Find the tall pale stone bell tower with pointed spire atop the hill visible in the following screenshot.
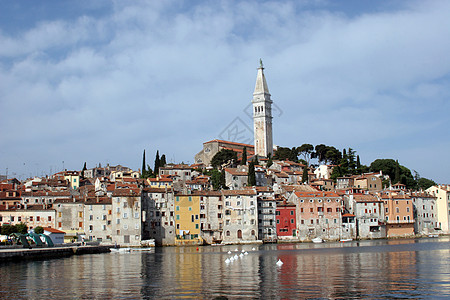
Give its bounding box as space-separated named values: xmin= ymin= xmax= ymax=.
xmin=252 ymin=60 xmax=273 ymax=157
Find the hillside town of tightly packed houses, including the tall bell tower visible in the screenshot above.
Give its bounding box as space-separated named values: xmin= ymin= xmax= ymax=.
xmin=0 ymin=62 xmax=450 ymax=246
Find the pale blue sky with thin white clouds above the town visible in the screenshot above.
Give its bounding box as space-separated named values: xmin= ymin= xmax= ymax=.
xmin=0 ymin=0 xmax=450 ymax=183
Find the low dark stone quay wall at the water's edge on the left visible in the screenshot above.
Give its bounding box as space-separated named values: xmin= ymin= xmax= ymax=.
xmin=0 ymin=246 xmax=110 ymax=263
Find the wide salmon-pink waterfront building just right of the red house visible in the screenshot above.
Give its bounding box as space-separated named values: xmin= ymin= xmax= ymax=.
xmin=288 ymin=190 xmax=342 ymax=241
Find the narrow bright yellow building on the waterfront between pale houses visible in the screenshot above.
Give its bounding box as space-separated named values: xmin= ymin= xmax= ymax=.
xmin=175 ymin=194 xmax=202 ymax=245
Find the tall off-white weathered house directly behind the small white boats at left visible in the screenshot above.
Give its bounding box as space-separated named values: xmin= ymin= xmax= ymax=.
xmin=111 ymin=188 xmax=142 ymax=246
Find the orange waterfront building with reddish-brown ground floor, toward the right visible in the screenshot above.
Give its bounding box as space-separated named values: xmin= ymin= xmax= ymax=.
xmin=381 ymin=193 xmax=414 ymax=237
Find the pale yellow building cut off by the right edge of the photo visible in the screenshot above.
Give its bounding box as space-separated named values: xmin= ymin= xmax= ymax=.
xmin=426 ymin=184 xmax=450 ymax=234
